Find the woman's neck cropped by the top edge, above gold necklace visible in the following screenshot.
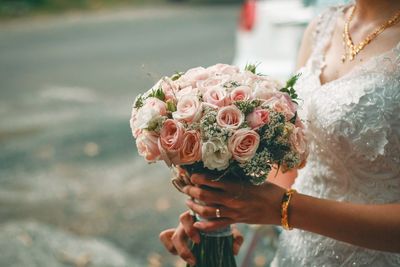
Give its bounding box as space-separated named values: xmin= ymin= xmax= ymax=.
xmin=354 ymin=0 xmax=400 ymax=22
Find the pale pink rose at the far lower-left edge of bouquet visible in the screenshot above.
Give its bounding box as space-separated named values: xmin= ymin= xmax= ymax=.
xmin=136 ymin=131 xmax=160 ymax=162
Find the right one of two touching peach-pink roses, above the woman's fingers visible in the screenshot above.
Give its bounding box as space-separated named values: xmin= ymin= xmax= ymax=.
xmin=179 ymin=130 xmax=201 ymax=165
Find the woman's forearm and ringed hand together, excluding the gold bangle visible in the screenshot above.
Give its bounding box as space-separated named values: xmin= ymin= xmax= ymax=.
xmin=184 ymin=175 xmax=400 ymax=253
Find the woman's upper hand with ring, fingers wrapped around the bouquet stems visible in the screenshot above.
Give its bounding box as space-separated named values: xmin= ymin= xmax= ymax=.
xmin=183 ymin=174 xmax=285 ymax=231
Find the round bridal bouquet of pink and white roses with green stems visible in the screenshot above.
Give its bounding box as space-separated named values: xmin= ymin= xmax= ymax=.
xmin=130 ymin=64 xmax=307 ymax=267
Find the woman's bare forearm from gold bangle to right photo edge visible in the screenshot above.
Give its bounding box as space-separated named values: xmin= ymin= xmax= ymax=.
xmin=289 ymin=194 xmax=400 ymax=253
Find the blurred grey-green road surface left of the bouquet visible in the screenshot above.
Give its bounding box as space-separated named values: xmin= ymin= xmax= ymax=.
xmin=0 ymin=6 xmax=238 ymax=267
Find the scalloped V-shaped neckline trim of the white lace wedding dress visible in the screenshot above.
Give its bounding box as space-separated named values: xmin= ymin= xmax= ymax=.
xmin=315 ymin=4 xmax=400 ymax=88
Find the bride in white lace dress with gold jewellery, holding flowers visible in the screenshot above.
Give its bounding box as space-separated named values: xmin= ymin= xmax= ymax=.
xmin=160 ymin=0 xmax=400 ymax=267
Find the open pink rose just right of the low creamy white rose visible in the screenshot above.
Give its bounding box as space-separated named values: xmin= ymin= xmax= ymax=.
xmin=228 ymin=129 xmax=260 ymax=163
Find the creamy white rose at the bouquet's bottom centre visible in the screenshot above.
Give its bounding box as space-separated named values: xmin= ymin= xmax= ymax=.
xmin=201 ymin=138 xmax=232 ymax=171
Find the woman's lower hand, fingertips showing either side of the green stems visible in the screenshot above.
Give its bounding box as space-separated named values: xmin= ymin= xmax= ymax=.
xmin=160 ymin=211 xmax=243 ymax=265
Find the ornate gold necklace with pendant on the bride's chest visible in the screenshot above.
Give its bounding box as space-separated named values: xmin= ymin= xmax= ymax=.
xmin=342 ymin=5 xmax=400 ymax=63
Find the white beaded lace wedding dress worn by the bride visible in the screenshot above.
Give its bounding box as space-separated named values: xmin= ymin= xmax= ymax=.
xmin=271 ymin=6 xmax=400 ymax=267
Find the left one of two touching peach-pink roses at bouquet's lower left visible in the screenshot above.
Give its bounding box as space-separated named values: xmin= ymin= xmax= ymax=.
xmin=158 ymin=119 xmax=185 ymax=166
